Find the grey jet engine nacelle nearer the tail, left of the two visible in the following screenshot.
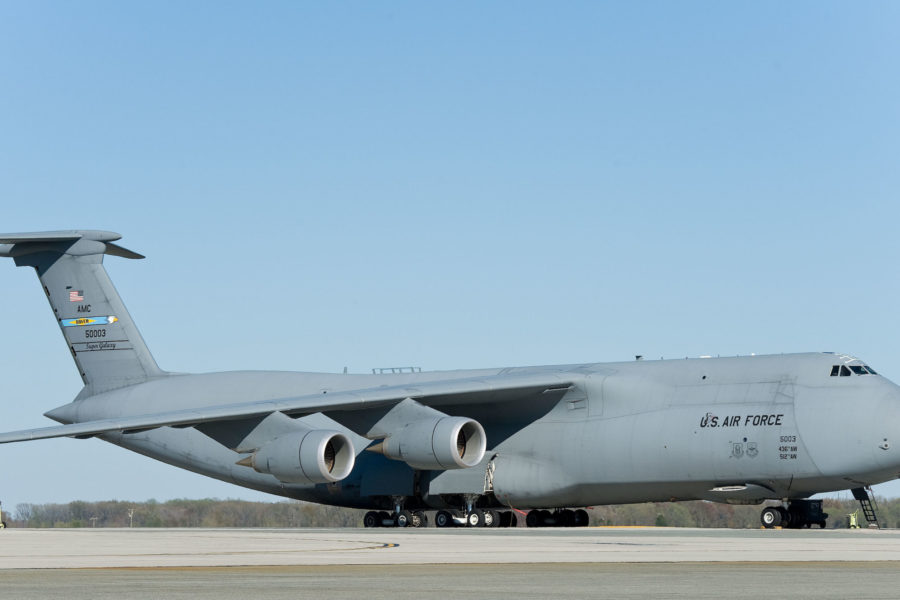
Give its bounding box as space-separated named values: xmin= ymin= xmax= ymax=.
xmin=250 ymin=429 xmax=356 ymax=483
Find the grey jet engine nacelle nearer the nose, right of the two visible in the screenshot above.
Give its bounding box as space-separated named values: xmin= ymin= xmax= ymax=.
xmin=381 ymin=417 xmax=487 ymax=470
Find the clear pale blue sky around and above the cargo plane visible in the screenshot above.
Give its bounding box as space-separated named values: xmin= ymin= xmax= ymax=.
xmin=0 ymin=1 xmax=900 ymax=509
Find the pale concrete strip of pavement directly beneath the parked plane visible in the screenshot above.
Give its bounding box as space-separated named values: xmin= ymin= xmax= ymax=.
xmin=0 ymin=527 xmax=900 ymax=569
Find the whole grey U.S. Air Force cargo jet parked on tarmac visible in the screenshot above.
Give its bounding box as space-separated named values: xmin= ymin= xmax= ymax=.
xmin=0 ymin=231 xmax=900 ymax=527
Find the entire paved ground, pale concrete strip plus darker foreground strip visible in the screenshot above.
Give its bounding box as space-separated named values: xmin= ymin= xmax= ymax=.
xmin=0 ymin=528 xmax=900 ymax=600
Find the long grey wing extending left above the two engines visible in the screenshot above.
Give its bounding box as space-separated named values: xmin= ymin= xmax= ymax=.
xmin=0 ymin=373 xmax=572 ymax=444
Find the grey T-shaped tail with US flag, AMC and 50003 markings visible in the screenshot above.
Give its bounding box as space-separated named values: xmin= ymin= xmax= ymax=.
xmin=0 ymin=231 xmax=165 ymax=394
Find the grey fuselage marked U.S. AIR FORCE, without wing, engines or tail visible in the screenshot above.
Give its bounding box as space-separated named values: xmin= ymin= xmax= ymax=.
xmin=48 ymin=353 xmax=900 ymax=508
